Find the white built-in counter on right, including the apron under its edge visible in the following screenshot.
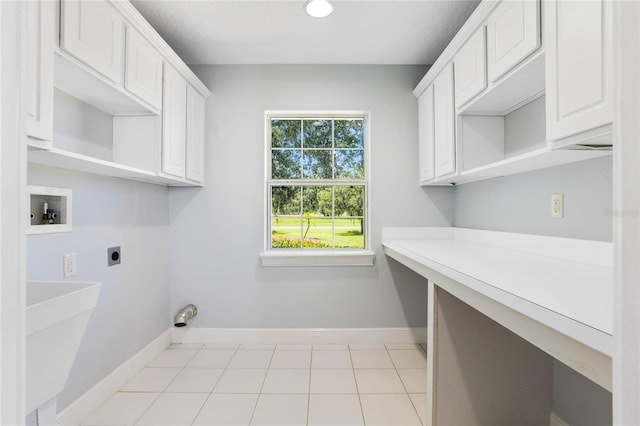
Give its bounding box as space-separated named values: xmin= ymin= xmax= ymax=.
xmin=382 ymin=228 xmax=614 ymax=389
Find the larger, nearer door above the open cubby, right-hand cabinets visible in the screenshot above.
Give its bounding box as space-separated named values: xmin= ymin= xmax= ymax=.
xmin=487 ymin=0 xmax=540 ymax=81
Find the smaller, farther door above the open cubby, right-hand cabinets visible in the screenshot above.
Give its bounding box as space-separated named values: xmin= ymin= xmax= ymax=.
xmin=453 ymin=26 xmax=487 ymax=107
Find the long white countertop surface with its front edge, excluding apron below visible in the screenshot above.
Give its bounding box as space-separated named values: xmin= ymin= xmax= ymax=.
xmin=382 ymin=228 xmax=613 ymax=356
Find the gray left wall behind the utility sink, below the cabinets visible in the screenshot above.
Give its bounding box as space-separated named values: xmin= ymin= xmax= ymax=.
xmin=27 ymin=164 xmax=171 ymax=410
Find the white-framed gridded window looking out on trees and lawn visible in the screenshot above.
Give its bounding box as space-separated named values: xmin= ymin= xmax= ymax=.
xmin=263 ymin=112 xmax=370 ymax=263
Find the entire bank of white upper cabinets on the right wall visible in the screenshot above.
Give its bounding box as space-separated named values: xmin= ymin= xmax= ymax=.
xmin=413 ymin=0 xmax=613 ymax=185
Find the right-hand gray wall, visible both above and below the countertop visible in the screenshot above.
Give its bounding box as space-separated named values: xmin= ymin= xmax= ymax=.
xmin=454 ymin=156 xmax=613 ymax=426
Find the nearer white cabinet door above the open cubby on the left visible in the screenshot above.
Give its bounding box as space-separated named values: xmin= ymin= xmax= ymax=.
xmin=60 ymin=0 xmax=124 ymax=84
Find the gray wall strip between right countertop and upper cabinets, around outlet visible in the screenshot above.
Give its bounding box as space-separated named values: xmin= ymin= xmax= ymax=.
xmin=454 ymin=156 xmax=612 ymax=241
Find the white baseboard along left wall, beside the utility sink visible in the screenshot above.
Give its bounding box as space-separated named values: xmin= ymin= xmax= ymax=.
xmin=57 ymin=330 xmax=172 ymax=426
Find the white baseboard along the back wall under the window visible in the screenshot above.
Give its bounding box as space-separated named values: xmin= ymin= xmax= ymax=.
xmin=171 ymin=327 xmax=427 ymax=345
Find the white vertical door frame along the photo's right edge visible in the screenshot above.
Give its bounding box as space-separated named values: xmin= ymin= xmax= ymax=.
xmin=612 ymin=1 xmax=640 ymax=425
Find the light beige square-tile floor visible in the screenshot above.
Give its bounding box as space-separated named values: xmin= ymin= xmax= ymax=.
xmin=82 ymin=344 xmax=427 ymax=426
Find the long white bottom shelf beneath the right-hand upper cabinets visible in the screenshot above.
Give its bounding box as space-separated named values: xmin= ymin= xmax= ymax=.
xmin=425 ymin=148 xmax=611 ymax=185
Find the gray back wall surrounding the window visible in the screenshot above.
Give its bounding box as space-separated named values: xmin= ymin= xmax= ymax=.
xmin=169 ymin=65 xmax=453 ymax=328
